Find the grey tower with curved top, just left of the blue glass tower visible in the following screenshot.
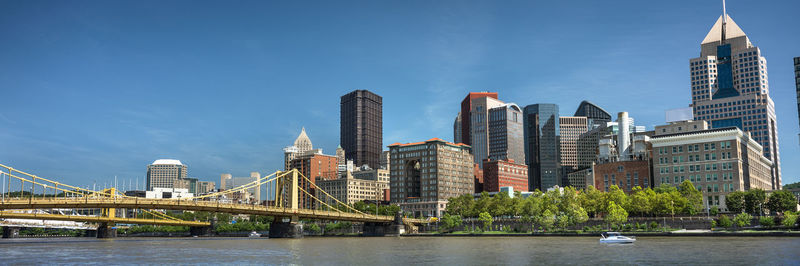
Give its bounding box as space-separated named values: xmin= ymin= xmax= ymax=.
xmin=488 ymin=103 xmax=527 ymax=164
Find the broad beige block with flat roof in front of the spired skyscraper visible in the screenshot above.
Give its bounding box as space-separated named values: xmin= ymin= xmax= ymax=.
xmin=650 ymin=122 xmax=773 ymax=211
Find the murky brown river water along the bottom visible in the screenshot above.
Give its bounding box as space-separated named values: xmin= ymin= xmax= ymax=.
xmin=0 ymin=237 xmax=800 ymax=266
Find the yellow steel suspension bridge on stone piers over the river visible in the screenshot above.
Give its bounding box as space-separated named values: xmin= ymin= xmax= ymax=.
xmin=0 ymin=164 xmax=427 ymax=238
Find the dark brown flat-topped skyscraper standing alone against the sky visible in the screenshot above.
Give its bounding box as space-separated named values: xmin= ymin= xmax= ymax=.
xmin=339 ymin=90 xmax=383 ymax=169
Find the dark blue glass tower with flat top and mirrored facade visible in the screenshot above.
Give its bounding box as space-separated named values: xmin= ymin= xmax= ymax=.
xmin=523 ymin=103 xmax=563 ymax=191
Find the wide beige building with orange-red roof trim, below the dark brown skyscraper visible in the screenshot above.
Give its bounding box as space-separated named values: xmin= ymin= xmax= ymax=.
xmin=389 ymin=138 xmax=475 ymax=217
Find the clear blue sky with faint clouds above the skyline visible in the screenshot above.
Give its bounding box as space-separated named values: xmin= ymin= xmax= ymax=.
xmin=0 ymin=0 xmax=800 ymax=189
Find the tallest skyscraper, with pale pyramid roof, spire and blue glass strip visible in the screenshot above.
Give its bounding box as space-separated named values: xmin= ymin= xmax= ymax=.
xmin=689 ymin=8 xmax=781 ymax=189
